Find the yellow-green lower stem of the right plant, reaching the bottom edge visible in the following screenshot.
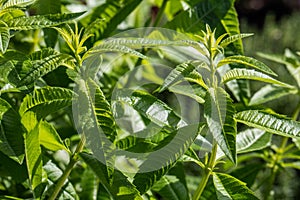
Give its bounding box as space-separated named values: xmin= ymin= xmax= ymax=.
xmin=193 ymin=144 xmax=218 ymax=200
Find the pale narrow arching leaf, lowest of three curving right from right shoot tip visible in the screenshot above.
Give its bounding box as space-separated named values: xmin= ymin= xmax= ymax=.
xmin=222 ymin=68 xmax=294 ymax=88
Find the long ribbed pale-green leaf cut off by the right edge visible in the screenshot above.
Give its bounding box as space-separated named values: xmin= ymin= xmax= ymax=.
xmin=235 ymin=110 xmax=300 ymax=137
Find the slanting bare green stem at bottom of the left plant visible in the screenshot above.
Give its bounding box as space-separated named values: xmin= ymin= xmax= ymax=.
xmin=49 ymin=135 xmax=85 ymax=200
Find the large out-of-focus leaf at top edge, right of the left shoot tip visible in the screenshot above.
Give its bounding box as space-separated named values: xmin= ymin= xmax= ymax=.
xmin=80 ymin=0 xmax=142 ymax=44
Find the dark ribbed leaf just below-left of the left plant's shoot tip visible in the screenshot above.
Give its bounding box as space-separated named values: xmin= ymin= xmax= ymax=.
xmin=17 ymin=48 xmax=72 ymax=86
